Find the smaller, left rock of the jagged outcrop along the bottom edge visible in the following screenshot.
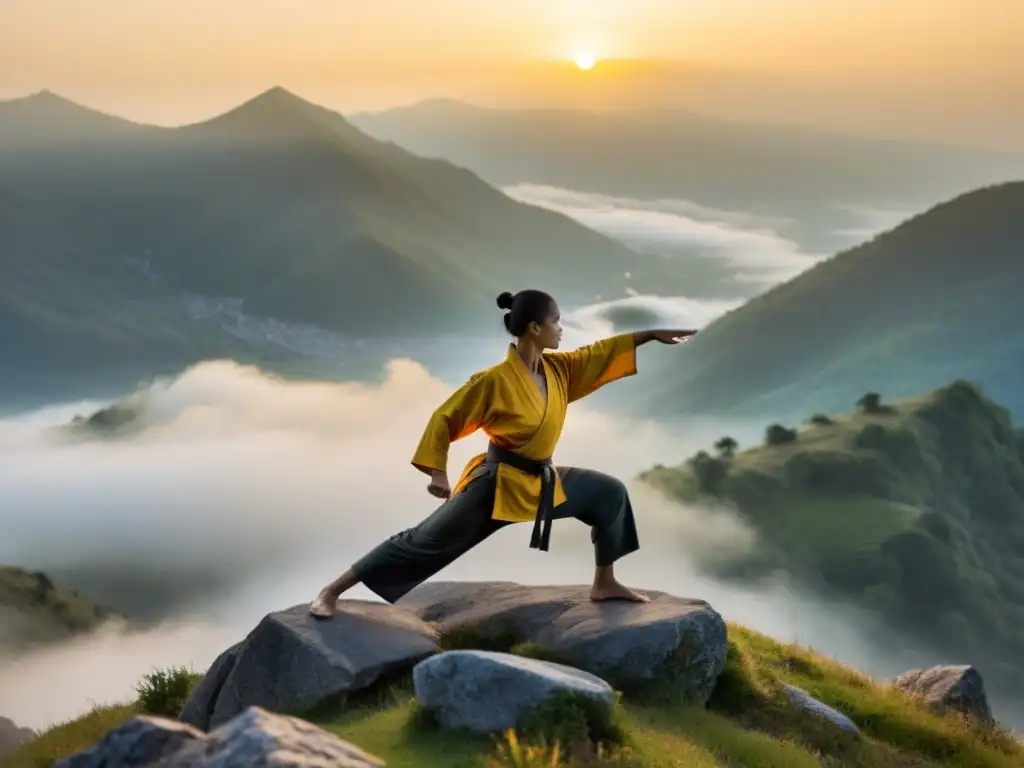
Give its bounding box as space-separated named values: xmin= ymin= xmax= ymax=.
xmin=54 ymin=716 xmax=205 ymax=768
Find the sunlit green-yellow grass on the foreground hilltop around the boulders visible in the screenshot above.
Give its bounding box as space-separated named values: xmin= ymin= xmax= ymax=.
xmin=7 ymin=626 xmax=1024 ymax=768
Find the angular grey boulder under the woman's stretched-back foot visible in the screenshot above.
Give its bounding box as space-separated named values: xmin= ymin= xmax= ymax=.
xmin=179 ymin=600 xmax=437 ymax=730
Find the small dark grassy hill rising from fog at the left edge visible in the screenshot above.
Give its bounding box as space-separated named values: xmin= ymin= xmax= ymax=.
xmin=0 ymin=566 xmax=116 ymax=655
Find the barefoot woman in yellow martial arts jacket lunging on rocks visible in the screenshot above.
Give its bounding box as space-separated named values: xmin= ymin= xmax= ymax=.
xmin=309 ymin=290 xmax=696 ymax=618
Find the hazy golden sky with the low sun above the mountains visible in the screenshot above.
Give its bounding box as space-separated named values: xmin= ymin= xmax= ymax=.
xmin=0 ymin=0 xmax=1024 ymax=145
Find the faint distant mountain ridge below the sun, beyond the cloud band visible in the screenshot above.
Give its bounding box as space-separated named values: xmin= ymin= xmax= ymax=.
xmin=349 ymin=99 xmax=1024 ymax=250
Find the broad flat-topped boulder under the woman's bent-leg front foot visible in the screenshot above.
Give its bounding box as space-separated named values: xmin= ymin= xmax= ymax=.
xmin=397 ymin=582 xmax=728 ymax=707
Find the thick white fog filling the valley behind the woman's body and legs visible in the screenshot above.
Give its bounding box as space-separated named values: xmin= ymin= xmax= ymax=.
xmin=0 ymin=358 xmax=950 ymax=728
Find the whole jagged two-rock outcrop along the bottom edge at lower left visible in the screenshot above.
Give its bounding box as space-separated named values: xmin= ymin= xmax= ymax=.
xmin=55 ymin=708 xmax=384 ymax=768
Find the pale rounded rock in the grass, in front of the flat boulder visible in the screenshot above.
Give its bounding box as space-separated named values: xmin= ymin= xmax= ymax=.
xmin=413 ymin=650 xmax=615 ymax=733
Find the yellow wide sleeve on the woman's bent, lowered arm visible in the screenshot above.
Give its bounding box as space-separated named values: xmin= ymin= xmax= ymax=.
xmin=413 ymin=373 xmax=494 ymax=473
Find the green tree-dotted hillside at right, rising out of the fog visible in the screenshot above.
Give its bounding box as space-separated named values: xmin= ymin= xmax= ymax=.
xmin=642 ymin=382 xmax=1024 ymax=699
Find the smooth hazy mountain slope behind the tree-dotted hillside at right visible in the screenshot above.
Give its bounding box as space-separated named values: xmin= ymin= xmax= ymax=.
xmin=629 ymin=182 xmax=1024 ymax=420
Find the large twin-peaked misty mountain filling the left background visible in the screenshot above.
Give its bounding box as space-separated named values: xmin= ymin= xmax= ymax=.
xmin=0 ymin=88 xmax=681 ymax=409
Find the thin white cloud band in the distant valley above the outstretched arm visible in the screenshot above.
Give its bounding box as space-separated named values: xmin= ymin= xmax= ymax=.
xmin=504 ymin=184 xmax=822 ymax=285
